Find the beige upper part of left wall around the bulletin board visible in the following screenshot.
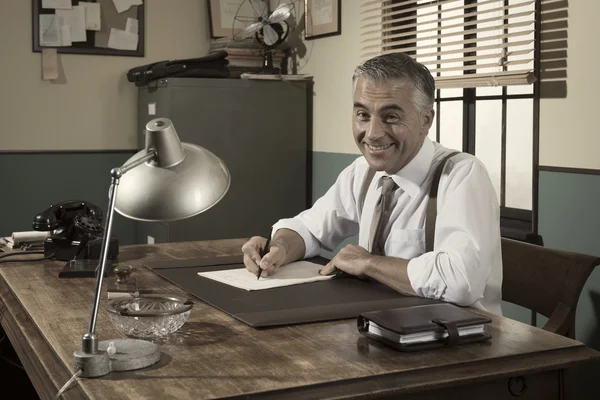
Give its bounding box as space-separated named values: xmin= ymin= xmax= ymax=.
xmin=0 ymin=0 xmax=210 ymax=151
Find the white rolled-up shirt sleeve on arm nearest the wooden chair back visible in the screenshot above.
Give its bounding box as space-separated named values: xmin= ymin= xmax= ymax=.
xmin=407 ymin=159 xmax=500 ymax=306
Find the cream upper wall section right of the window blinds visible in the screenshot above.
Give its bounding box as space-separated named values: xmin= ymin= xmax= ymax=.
xmin=540 ymin=0 xmax=600 ymax=169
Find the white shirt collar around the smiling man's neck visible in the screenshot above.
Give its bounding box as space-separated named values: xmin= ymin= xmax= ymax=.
xmin=375 ymin=137 xmax=435 ymax=197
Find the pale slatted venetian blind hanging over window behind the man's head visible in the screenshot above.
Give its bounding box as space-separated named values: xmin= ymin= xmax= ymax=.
xmin=361 ymin=0 xmax=536 ymax=88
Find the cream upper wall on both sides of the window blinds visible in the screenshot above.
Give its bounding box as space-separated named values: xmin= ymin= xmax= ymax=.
xmin=298 ymin=0 xmax=600 ymax=169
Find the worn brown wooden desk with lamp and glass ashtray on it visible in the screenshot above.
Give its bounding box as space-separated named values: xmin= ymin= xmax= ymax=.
xmin=0 ymin=239 xmax=599 ymax=399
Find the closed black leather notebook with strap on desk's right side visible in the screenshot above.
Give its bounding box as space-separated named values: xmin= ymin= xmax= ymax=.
xmin=357 ymin=303 xmax=491 ymax=351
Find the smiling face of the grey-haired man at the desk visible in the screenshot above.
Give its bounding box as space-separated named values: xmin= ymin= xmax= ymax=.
xmin=352 ymin=77 xmax=434 ymax=174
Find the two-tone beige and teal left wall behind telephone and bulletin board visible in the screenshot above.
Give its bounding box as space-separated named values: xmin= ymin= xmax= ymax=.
xmin=0 ymin=0 xmax=210 ymax=244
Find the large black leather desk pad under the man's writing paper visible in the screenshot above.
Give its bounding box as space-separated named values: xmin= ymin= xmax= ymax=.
xmin=144 ymin=256 xmax=437 ymax=328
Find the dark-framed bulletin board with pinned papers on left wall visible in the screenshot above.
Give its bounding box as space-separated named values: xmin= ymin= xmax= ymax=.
xmin=32 ymin=0 xmax=145 ymax=57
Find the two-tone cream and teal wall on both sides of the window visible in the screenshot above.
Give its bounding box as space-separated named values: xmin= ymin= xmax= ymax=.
xmin=298 ymin=0 xmax=600 ymax=356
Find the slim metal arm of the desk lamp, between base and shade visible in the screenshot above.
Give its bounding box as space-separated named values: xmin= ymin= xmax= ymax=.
xmin=82 ymin=149 xmax=157 ymax=354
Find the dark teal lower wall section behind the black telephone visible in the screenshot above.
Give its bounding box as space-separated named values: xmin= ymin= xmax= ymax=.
xmin=0 ymin=152 xmax=135 ymax=245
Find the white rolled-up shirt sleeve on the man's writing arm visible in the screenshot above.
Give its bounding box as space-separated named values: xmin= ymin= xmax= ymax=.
xmin=271 ymin=161 xmax=358 ymax=258
